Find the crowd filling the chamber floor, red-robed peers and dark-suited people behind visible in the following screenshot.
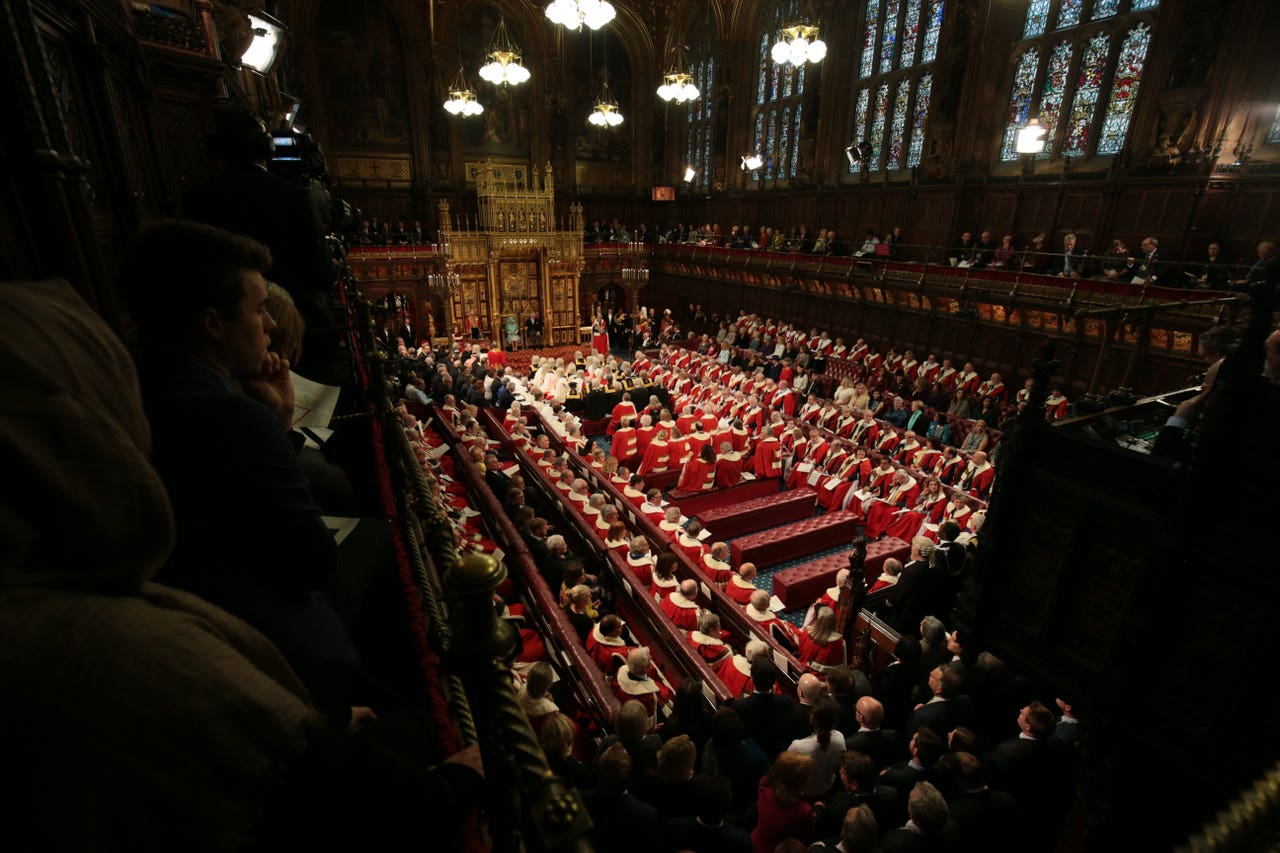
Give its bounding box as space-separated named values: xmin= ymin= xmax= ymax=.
xmin=381 ymin=297 xmax=1078 ymax=850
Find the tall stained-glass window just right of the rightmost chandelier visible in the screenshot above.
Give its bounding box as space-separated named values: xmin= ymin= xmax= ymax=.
xmin=849 ymin=0 xmax=943 ymax=172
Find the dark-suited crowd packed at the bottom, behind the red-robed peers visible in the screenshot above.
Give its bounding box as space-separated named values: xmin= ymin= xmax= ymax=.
xmin=476 ymin=394 xmax=1073 ymax=849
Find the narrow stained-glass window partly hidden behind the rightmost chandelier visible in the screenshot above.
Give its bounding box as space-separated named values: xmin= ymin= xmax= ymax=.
xmin=749 ymin=0 xmax=803 ymax=182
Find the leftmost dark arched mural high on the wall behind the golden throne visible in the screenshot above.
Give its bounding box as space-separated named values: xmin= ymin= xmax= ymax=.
xmin=316 ymin=0 xmax=410 ymax=149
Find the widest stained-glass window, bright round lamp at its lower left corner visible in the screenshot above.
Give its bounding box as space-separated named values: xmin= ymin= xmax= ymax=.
xmin=998 ymin=0 xmax=1160 ymax=161
